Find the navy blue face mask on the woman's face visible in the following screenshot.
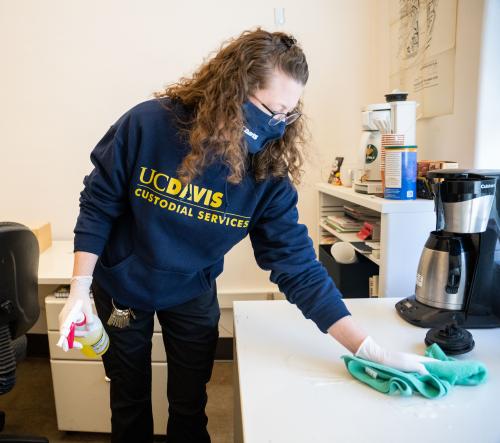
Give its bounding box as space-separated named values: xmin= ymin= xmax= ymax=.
xmin=243 ymin=101 xmax=286 ymax=154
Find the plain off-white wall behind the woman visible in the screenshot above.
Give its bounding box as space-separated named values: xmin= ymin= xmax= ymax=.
xmin=0 ymin=0 xmax=385 ymax=290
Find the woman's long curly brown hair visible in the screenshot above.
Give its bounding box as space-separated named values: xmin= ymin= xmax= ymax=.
xmin=154 ymin=28 xmax=309 ymax=184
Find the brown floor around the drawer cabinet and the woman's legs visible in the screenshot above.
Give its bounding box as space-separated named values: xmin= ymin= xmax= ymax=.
xmin=0 ymin=357 xmax=233 ymax=443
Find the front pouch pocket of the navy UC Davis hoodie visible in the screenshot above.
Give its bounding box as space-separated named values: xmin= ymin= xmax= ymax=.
xmin=98 ymin=253 xmax=210 ymax=309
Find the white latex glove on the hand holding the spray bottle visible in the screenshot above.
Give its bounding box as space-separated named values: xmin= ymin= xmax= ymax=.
xmin=57 ymin=275 xmax=93 ymax=352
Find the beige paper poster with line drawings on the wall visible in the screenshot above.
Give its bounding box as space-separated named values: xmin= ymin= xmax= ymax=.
xmin=389 ymin=0 xmax=457 ymax=118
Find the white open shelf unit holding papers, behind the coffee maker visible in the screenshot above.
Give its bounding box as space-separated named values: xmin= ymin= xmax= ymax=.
xmin=316 ymin=183 xmax=436 ymax=298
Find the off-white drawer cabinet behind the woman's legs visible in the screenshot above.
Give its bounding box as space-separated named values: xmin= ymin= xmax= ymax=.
xmin=45 ymin=295 xmax=168 ymax=435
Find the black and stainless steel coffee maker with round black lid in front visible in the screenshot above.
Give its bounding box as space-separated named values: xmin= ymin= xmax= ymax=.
xmin=396 ymin=169 xmax=500 ymax=353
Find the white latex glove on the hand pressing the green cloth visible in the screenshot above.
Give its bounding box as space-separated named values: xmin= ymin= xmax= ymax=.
xmin=354 ymin=336 xmax=436 ymax=375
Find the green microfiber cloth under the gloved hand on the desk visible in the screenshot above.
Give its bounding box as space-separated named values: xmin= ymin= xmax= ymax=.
xmin=342 ymin=343 xmax=488 ymax=399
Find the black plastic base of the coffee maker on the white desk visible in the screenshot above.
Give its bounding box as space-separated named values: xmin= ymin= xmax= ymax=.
xmin=396 ymin=295 xmax=500 ymax=329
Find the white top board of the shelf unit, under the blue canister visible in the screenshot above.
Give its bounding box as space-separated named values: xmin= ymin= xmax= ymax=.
xmin=316 ymin=183 xmax=434 ymax=213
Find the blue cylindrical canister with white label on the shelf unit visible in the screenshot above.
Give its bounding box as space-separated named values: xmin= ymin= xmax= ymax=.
xmin=384 ymin=145 xmax=417 ymax=200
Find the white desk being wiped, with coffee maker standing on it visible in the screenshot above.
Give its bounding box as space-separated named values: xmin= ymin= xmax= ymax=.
xmin=234 ymin=298 xmax=500 ymax=443
